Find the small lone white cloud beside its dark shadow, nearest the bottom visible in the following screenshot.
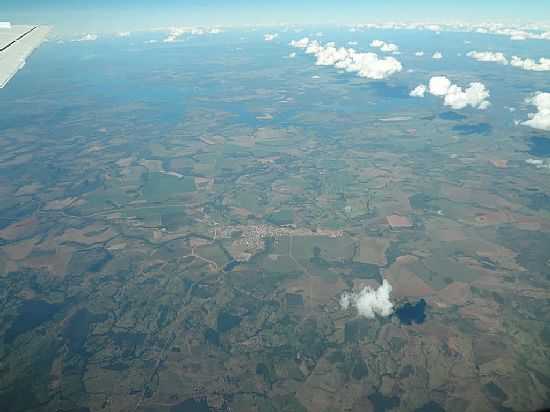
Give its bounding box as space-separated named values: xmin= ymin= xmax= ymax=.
xmin=340 ymin=279 xmax=393 ymax=319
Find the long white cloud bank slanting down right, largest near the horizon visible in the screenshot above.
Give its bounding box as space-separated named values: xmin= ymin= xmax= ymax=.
xmin=290 ymin=38 xmax=403 ymax=80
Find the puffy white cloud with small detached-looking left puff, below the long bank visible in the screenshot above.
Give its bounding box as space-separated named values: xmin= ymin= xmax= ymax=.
xmin=409 ymin=76 xmax=491 ymax=110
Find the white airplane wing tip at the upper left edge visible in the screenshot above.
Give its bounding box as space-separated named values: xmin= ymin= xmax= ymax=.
xmin=0 ymin=25 xmax=50 ymax=89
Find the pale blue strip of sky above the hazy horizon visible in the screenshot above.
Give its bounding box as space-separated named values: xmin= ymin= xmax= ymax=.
xmin=0 ymin=0 xmax=550 ymax=33
